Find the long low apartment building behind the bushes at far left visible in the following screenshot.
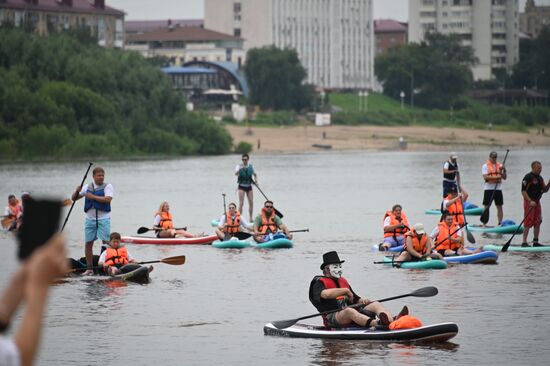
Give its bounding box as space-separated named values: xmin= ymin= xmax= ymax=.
xmin=0 ymin=0 xmax=125 ymax=47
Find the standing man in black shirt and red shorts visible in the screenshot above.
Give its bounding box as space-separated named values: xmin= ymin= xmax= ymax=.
xmin=521 ymin=161 xmax=550 ymax=247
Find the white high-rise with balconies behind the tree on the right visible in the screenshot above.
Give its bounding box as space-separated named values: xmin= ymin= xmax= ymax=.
xmin=409 ymin=0 xmax=519 ymax=80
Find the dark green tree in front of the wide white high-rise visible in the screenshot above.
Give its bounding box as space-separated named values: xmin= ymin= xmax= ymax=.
xmin=245 ymin=46 xmax=313 ymax=110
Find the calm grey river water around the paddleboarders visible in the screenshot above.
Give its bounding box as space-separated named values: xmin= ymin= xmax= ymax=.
xmin=0 ymin=150 xmax=550 ymax=366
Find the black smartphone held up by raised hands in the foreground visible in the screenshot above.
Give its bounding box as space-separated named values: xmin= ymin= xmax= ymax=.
xmin=18 ymin=198 xmax=61 ymax=260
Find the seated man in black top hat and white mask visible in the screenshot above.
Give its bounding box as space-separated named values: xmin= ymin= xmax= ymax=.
xmin=309 ymin=251 xmax=409 ymax=328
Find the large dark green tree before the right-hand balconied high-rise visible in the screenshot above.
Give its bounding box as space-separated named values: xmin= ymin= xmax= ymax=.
xmin=375 ymin=33 xmax=476 ymax=108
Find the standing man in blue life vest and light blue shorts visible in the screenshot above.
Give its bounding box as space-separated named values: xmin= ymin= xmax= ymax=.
xmin=71 ymin=166 xmax=114 ymax=275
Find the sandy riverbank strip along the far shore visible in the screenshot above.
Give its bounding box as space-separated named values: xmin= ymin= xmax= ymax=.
xmin=227 ymin=125 xmax=550 ymax=154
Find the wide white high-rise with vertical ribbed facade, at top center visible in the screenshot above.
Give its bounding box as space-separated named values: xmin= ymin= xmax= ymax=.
xmin=204 ymin=0 xmax=374 ymax=89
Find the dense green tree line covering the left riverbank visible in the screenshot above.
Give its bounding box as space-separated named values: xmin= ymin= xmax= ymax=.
xmin=0 ymin=26 xmax=232 ymax=159
